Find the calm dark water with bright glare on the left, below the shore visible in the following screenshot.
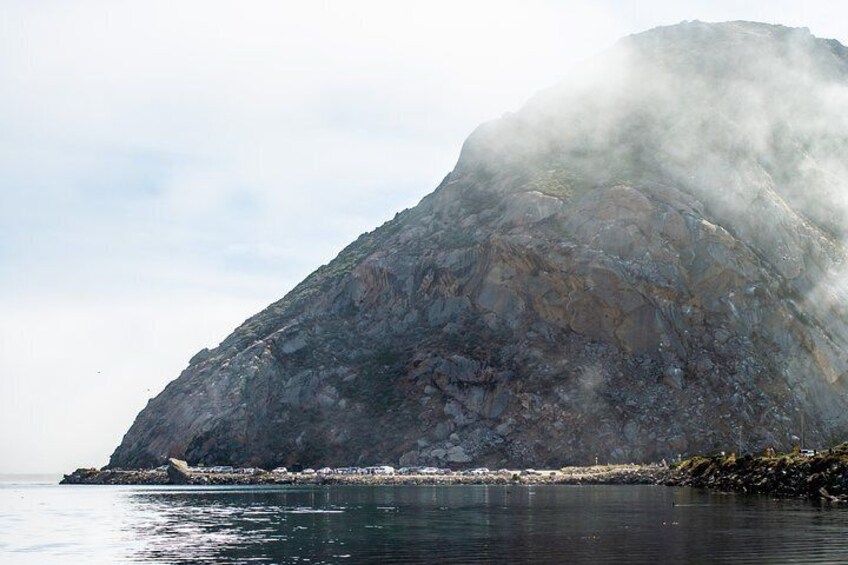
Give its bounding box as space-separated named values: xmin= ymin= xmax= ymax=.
xmin=0 ymin=476 xmax=848 ymax=565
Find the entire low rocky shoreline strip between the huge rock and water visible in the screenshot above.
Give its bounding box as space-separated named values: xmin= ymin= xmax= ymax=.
xmin=60 ymin=443 xmax=848 ymax=503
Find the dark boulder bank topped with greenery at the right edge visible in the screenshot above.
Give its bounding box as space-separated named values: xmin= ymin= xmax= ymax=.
xmin=664 ymin=444 xmax=848 ymax=502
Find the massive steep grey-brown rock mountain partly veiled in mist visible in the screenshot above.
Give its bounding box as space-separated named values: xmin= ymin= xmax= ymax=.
xmin=110 ymin=22 xmax=848 ymax=467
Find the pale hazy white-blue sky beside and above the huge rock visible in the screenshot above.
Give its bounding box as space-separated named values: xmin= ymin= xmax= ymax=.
xmin=0 ymin=0 xmax=848 ymax=473
